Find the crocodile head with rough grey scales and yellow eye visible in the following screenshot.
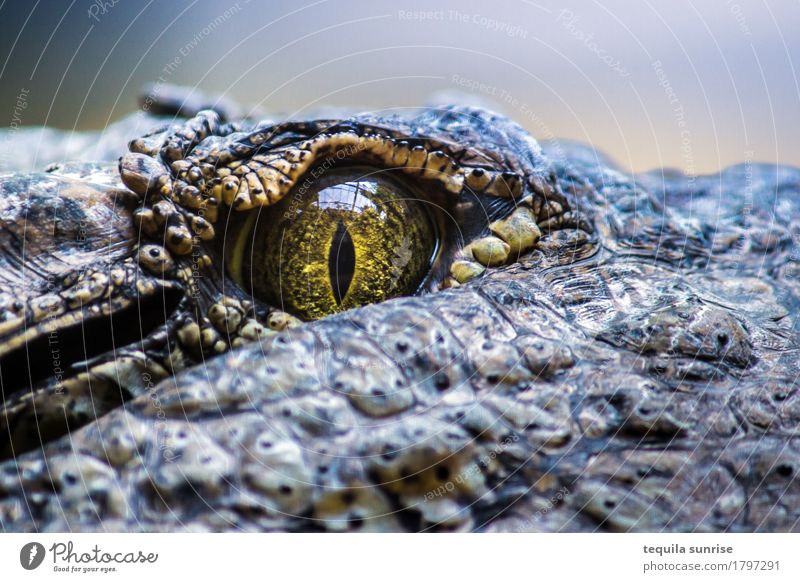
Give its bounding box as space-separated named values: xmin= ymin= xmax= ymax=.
xmin=0 ymin=88 xmax=800 ymax=532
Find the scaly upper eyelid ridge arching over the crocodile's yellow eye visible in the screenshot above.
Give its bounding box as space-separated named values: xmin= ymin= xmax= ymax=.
xmin=120 ymin=110 xmax=574 ymax=290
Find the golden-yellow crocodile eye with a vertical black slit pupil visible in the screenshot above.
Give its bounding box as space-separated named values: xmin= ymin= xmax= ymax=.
xmin=226 ymin=168 xmax=439 ymax=320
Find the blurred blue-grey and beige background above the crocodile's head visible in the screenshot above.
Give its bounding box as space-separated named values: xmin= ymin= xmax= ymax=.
xmin=0 ymin=0 xmax=800 ymax=174
